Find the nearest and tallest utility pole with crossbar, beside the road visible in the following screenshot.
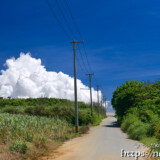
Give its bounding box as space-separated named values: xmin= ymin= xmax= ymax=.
xmin=70 ymin=40 xmax=84 ymax=132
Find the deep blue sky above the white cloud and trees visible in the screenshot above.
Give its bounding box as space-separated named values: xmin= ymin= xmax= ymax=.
xmin=0 ymin=0 xmax=160 ymax=104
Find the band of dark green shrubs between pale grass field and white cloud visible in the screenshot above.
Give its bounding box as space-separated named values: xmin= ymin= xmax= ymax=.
xmin=0 ymin=98 xmax=106 ymax=125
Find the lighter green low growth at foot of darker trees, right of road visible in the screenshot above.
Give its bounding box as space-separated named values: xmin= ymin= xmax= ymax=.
xmin=121 ymin=113 xmax=160 ymax=159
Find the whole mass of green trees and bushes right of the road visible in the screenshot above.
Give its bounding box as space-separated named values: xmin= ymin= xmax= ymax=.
xmin=112 ymin=80 xmax=160 ymax=145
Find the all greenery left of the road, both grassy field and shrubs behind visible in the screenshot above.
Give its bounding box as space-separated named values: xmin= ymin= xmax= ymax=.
xmin=0 ymin=98 xmax=105 ymax=159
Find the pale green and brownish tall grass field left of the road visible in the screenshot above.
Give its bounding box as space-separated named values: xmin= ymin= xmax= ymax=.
xmin=0 ymin=113 xmax=73 ymax=159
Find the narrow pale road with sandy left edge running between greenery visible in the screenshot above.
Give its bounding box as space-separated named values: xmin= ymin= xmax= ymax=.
xmin=42 ymin=116 xmax=143 ymax=160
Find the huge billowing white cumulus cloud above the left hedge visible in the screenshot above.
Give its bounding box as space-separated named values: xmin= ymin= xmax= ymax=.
xmin=0 ymin=53 xmax=106 ymax=103
